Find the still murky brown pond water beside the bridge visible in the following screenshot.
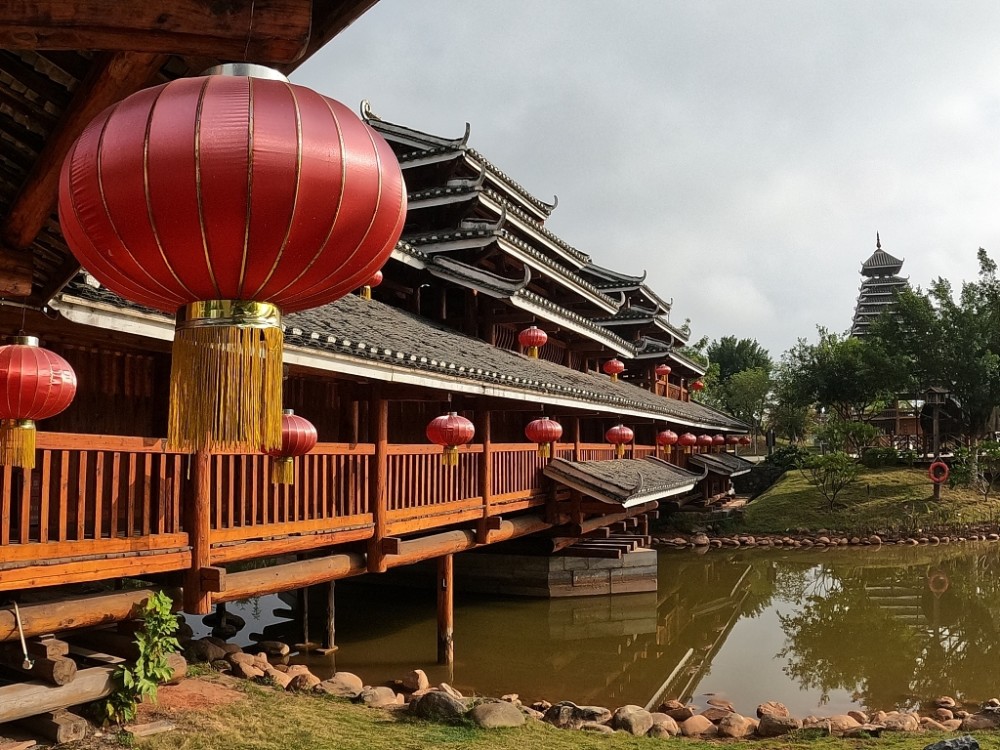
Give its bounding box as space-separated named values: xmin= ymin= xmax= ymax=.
xmin=189 ymin=543 xmax=1000 ymax=716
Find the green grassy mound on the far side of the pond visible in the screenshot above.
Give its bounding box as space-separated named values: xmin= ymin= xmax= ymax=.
xmin=726 ymin=468 xmax=1000 ymax=535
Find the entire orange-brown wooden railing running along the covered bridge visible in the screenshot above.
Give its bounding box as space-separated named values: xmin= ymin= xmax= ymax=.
xmin=0 ymin=433 xmax=672 ymax=590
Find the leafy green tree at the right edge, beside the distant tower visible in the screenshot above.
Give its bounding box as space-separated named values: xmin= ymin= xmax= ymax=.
xmin=872 ymin=248 xmax=1000 ymax=474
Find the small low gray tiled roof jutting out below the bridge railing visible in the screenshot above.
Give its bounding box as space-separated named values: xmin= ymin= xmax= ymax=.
xmin=543 ymin=458 xmax=705 ymax=505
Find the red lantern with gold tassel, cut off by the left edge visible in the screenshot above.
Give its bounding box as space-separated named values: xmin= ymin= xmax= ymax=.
xmin=0 ymin=336 xmax=76 ymax=469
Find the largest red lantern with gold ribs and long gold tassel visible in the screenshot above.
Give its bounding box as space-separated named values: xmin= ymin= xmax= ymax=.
xmin=59 ymin=65 xmax=406 ymax=453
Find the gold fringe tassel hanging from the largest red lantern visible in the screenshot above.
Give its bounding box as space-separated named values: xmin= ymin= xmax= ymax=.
xmin=167 ymin=300 xmax=284 ymax=453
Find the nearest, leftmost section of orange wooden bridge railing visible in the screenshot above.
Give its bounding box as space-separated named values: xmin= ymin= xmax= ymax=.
xmin=0 ymin=433 xmax=190 ymax=589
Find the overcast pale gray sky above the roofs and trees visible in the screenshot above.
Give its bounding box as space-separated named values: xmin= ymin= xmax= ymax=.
xmin=293 ymin=0 xmax=1000 ymax=358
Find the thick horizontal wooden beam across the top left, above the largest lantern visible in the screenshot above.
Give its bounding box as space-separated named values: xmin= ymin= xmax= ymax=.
xmin=0 ymin=0 xmax=310 ymax=63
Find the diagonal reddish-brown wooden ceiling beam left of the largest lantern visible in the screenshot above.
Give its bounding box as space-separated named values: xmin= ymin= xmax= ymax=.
xmin=0 ymin=47 xmax=166 ymax=302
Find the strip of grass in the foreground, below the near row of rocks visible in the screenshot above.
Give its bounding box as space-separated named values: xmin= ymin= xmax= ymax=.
xmin=135 ymin=677 xmax=1000 ymax=750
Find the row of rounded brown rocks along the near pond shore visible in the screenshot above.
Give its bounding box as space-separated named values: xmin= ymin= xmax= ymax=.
xmin=176 ymin=637 xmax=1000 ymax=750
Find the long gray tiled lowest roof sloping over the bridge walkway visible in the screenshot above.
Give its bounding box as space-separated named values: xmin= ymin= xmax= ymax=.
xmin=58 ymin=277 xmax=746 ymax=432
